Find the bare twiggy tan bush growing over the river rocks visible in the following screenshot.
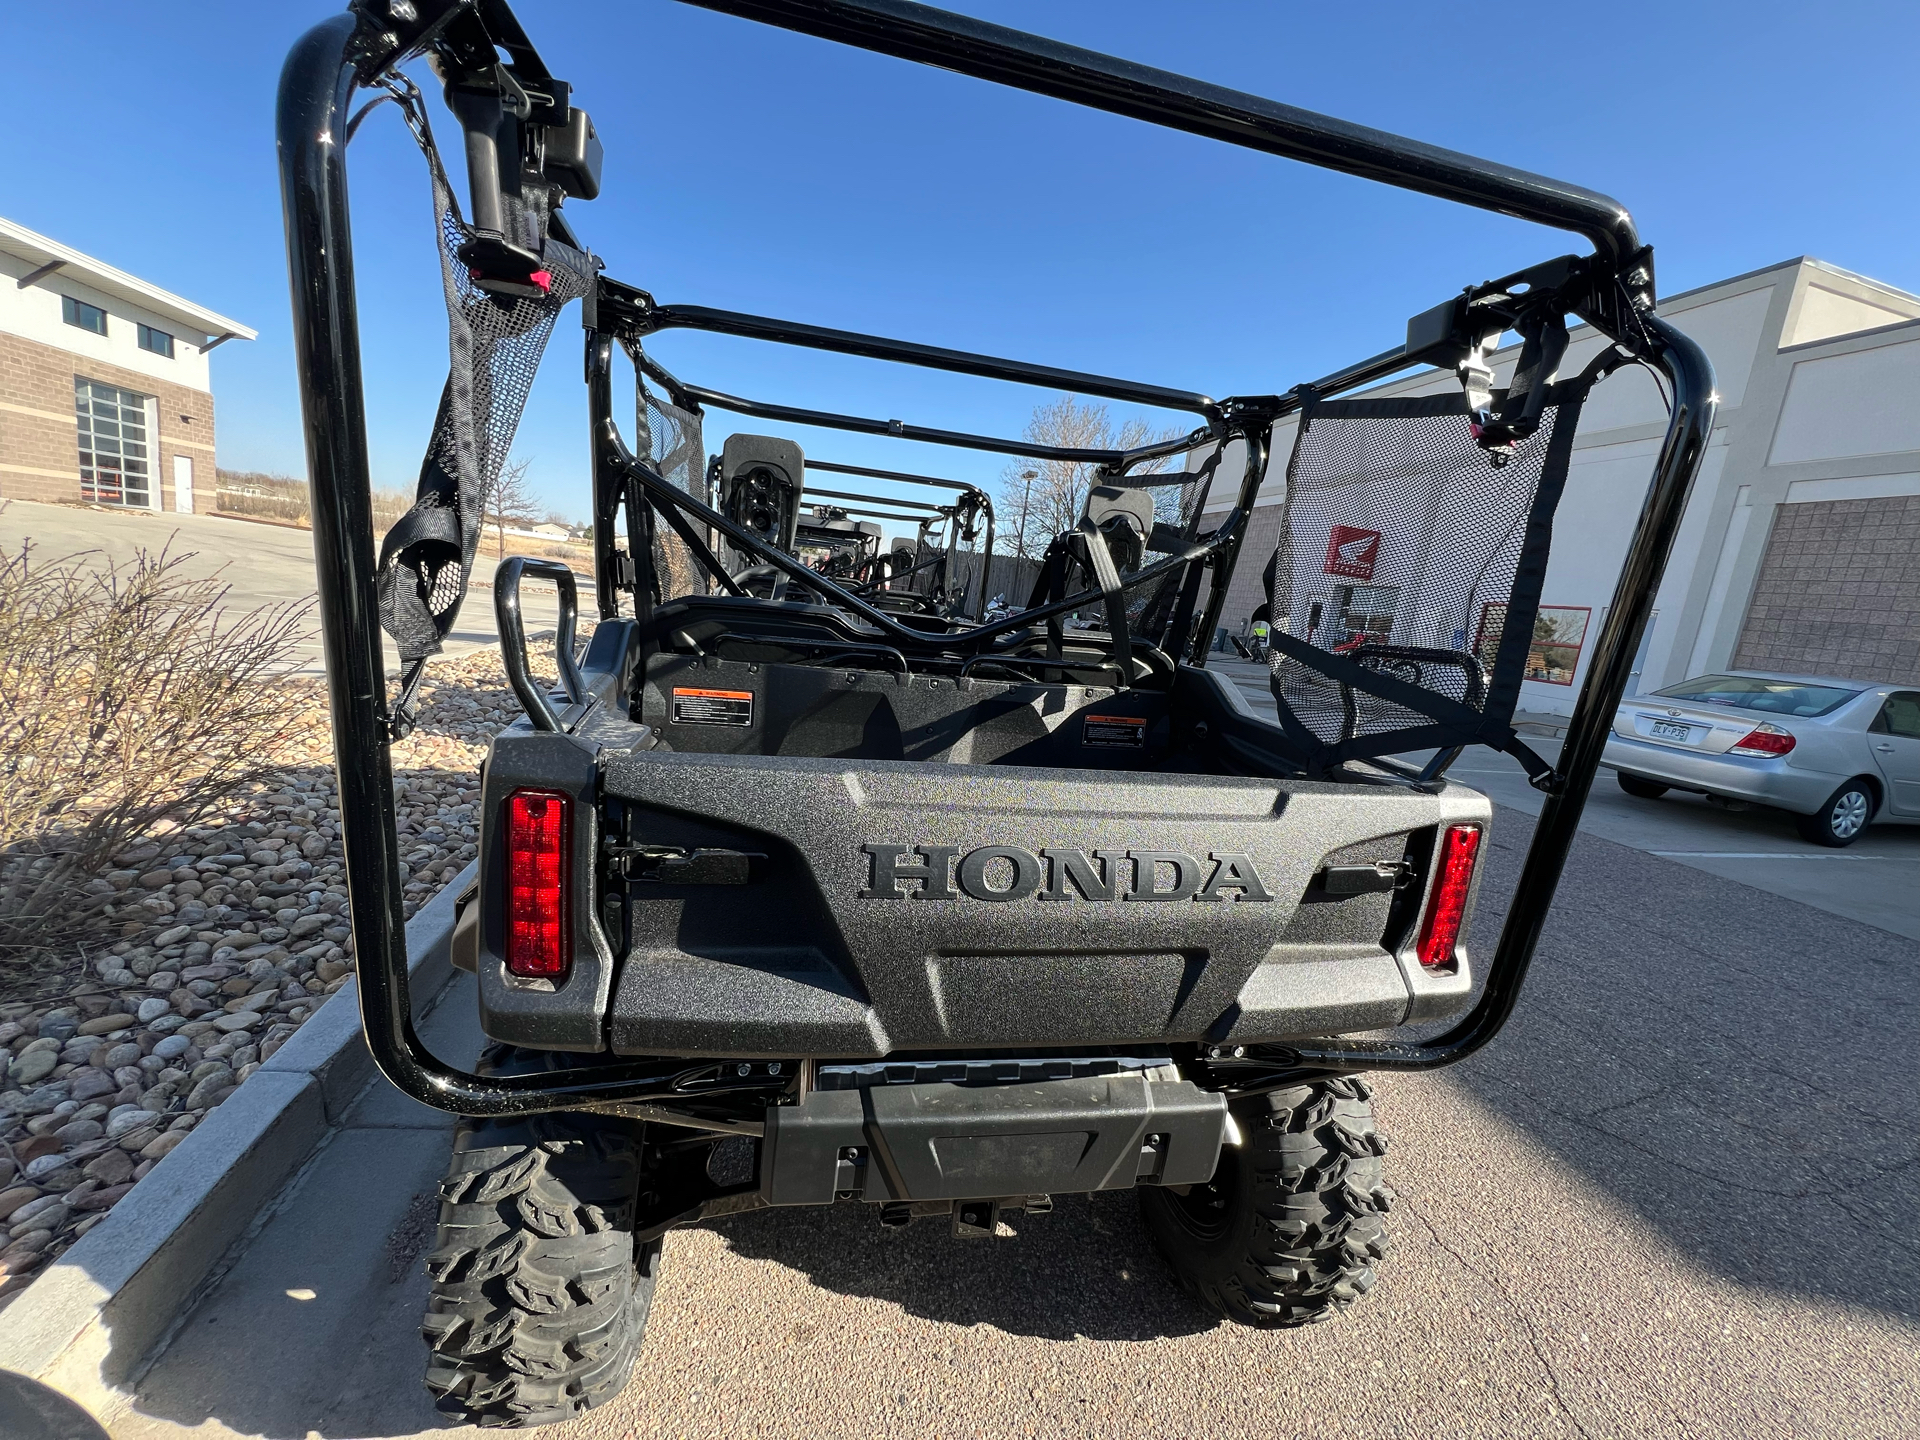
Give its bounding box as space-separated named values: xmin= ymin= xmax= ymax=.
xmin=0 ymin=543 xmax=305 ymax=975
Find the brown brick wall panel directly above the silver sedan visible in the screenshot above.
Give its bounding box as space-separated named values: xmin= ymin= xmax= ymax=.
xmin=1734 ymin=495 xmax=1920 ymax=682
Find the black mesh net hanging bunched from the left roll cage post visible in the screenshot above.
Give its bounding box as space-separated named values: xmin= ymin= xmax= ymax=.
xmin=368 ymin=92 xmax=593 ymax=679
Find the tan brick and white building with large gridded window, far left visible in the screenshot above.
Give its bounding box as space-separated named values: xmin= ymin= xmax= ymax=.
xmin=0 ymin=219 xmax=255 ymax=511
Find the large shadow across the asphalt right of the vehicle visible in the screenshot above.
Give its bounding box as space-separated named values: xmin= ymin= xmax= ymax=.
xmin=1448 ymin=808 xmax=1920 ymax=1317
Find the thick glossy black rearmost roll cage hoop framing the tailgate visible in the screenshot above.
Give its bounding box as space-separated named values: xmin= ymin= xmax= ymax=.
xmin=276 ymin=0 xmax=1718 ymax=1116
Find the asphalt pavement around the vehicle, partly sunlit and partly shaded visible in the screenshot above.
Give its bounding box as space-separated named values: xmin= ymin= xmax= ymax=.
xmin=111 ymin=808 xmax=1920 ymax=1440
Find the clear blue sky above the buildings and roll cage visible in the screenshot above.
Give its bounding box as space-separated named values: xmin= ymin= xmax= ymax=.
xmin=0 ymin=0 xmax=1920 ymax=515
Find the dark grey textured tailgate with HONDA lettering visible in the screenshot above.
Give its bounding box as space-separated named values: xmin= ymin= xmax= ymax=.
xmin=603 ymin=744 xmax=1490 ymax=1058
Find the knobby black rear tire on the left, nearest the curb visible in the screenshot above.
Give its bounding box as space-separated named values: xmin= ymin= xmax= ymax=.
xmin=420 ymin=1046 xmax=660 ymax=1427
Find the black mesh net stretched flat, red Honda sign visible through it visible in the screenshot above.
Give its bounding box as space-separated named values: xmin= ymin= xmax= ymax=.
xmin=1269 ymin=374 xmax=1594 ymax=774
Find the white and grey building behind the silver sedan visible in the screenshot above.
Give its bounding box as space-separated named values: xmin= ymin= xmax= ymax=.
xmin=1213 ymin=257 xmax=1920 ymax=714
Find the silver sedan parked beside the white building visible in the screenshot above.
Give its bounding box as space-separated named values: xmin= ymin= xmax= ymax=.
xmin=1601 ymin=670 xmax=1920 ymax=845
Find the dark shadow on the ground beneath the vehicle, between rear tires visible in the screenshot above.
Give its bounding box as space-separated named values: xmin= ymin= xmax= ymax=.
xmin=710 ymin=1192 xmax=1221 ymax=1340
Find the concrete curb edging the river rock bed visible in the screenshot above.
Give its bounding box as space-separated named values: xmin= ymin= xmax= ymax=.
xmin=0 ymin=864 xmax=474 ymax=1415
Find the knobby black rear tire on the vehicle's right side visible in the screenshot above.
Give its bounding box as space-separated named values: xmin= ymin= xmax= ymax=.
xmin=1140 ymin=1075 xmax=1394 ymax=1329
